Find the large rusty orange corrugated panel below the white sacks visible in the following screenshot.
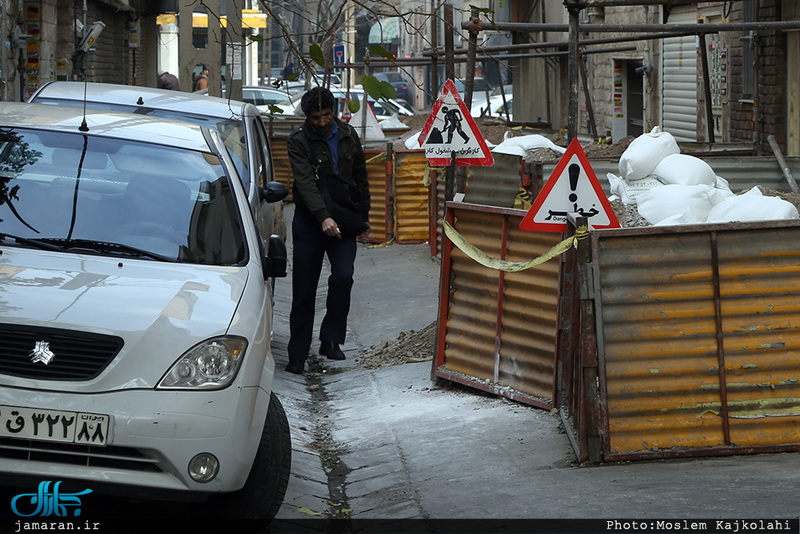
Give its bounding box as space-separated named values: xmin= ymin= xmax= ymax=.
xmin=593 ymin=221 xmax=800 ymax=459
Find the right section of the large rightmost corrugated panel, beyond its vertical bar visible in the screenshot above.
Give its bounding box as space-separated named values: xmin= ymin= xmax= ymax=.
xmin=717 ymin=226 xmax=800 ymax=446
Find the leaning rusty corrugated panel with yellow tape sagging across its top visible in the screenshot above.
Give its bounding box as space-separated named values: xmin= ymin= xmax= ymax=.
xmin=434 ymin=203 xmax=560 ymax=406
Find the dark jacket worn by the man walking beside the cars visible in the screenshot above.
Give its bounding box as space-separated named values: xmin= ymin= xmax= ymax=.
xmin=286 ymin=118 xmax=370 ymax=223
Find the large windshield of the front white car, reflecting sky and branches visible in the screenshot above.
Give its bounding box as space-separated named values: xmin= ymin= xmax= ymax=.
xmin=0 ymin=128 xmax=246 ymax=265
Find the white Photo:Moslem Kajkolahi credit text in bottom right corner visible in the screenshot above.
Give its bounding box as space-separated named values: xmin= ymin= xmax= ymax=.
xmin=606 ymin=519 xmax=798 ymax=534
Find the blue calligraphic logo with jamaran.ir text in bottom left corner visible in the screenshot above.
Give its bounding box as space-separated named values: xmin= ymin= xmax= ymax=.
xmin=11 ymin=480 xmax=100 ymax=532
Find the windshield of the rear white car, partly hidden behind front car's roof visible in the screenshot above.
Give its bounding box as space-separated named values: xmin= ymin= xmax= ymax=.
xmin=29 ymin=96 xmax=250 ymax=195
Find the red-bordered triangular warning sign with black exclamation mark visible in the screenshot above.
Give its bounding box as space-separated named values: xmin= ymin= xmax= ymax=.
xmin=519 ymin=139 xmax=619 ymax=232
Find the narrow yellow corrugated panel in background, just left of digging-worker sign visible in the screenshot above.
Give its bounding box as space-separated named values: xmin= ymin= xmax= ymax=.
xmin=394 ymin=150 xmax=429 ymax=243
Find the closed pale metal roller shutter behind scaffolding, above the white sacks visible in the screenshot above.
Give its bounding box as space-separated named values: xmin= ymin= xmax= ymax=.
xmin=661 ymin=6 xmax=698 ymax=141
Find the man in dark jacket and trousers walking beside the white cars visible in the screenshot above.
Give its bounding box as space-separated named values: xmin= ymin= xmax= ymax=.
xmin=286 ymin=87 xmax=370 ymax=374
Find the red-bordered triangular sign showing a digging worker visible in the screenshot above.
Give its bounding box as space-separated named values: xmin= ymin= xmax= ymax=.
xmin=419 ymin=80 xmax=494 ymax=167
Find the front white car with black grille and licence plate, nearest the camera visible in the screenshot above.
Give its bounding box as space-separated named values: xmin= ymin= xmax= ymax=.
xmin=0 ymin=103 xmax=291 ymax=521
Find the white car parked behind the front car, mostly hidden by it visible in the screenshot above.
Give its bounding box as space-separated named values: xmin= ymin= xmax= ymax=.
xmin=30 ymin=82 xmax=286 ymax=276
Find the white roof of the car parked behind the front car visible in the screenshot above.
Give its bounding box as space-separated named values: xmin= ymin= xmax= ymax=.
xmin=30 ymin=81 xmax=259 ymax=119
